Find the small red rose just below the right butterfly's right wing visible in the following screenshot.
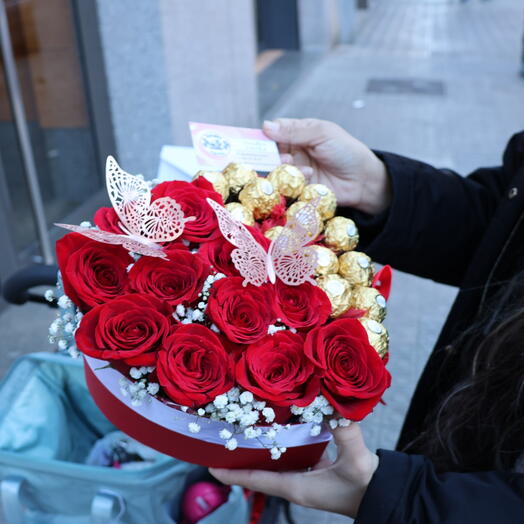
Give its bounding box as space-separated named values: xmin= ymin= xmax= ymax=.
xmin=275 ymin=280 xmax=331 ymax=329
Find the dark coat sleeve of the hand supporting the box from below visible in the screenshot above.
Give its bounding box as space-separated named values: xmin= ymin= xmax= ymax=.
xmin=355 ymin=450 xmax=524 ymax=524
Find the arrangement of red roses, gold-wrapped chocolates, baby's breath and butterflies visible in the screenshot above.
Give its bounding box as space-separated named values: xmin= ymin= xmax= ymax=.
xmin=49 ymin=157 xmax=391 ymax=468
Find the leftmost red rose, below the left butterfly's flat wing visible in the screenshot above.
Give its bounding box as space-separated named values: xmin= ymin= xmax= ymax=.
xmin=56 ymin=233 xmax=133 ymax=312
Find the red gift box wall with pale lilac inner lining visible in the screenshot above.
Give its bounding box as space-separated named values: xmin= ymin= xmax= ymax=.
xmin=84 ymin=356 xmax=331 ymax=471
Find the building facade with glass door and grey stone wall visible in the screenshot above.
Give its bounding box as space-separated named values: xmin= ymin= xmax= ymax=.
xmin=0 ymin=0 xmax=356 ymax=281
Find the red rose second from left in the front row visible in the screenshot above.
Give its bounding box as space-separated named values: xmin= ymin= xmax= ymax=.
xmin=156 ymin=324 xmax=233 ymax=407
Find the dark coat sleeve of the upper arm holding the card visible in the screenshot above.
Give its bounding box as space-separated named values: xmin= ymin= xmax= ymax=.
xmin=338 ymin=133 xmax=524 ymax=285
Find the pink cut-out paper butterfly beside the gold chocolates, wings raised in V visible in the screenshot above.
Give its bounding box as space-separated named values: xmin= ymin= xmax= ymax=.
xmin=207 ymin=198 xmax=318 ymax=286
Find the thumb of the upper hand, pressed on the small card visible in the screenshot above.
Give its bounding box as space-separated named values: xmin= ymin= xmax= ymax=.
xmin=262 ymin=118 xmax=327 ymax=146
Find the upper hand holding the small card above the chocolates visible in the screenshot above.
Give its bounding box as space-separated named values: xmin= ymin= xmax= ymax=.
xmin=262 ymin=118 xmax=391 ymax=215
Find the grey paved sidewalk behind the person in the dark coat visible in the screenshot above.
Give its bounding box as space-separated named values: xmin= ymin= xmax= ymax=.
xmin=270 ymin=0 xmax=524 ymax=524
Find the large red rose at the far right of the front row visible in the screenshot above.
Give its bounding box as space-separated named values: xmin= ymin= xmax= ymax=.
xmin=304 ymin=318 xmax=391 ymax=420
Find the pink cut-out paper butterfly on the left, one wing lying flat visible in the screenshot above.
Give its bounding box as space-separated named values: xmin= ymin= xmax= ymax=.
xmin=55 ymin=156 xmax=194 ymax=259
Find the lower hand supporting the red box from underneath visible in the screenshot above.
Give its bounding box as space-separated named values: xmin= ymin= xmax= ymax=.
xmin=209 ymin=423 xmax=378 ymax=518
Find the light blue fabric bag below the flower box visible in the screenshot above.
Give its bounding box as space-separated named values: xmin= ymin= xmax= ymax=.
xmin=0 ymin=353 xmax=248 ymax=524
